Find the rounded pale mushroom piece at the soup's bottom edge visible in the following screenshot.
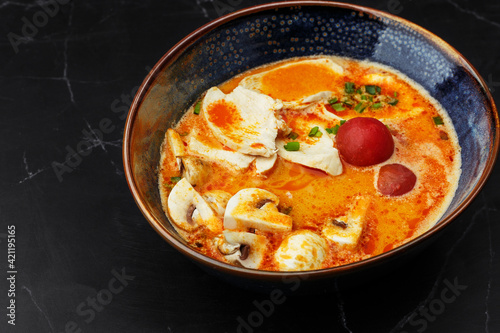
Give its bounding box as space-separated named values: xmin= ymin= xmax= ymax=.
xmin=274 ymin=230 xmax=328 ymax=271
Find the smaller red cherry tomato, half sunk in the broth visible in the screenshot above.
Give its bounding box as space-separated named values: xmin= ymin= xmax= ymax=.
xmin=377 ymin=163 xmax=417 ymax=196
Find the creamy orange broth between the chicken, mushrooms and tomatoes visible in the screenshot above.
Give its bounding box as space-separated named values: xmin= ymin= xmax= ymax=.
xmin=160 ymin=58 xmax=461 ymax=270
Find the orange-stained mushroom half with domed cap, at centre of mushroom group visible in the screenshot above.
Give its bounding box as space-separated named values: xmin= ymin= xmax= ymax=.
xmin=224 ymin=188 xmax=292 ymax=232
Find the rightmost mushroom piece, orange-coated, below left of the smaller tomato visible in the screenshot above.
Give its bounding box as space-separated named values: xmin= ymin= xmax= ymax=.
xmin=323 ymin=197 xmax=370 ymax=248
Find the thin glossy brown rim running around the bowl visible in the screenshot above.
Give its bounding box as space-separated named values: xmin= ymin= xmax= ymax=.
xmin=122 ymin=1 xmax=500 ymax=281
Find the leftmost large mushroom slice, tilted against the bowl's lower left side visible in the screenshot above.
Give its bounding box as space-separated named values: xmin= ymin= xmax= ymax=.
xmin=167 ymin=178 xmax=222 ymax=232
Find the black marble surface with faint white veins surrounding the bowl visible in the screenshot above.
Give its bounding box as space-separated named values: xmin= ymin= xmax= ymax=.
xmin=0 ymin=0 xmax=500 ymax=333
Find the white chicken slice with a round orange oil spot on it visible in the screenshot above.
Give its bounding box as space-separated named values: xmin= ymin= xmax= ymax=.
xmin=202 ymin=87 xmax=283 ymax=157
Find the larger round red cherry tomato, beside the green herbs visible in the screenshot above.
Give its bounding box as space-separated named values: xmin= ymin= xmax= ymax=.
xmin=337 ymin=117 xmax=394 ymax=166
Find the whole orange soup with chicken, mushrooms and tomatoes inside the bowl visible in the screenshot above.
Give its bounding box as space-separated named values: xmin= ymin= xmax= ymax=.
xmin=159 ymin=56 xmax=461 ymax=271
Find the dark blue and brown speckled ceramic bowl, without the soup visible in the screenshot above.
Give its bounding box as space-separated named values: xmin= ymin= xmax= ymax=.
xmin=123 ymin=1 xmax=499 ymax=289
